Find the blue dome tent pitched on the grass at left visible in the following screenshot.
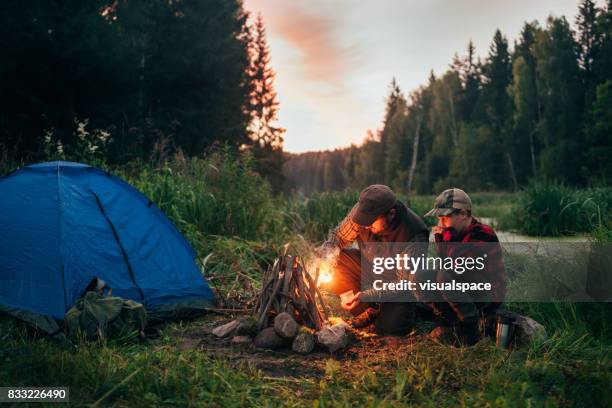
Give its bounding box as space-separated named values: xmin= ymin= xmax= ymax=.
xmin=0 ymin=162 xmax=214 ymax=330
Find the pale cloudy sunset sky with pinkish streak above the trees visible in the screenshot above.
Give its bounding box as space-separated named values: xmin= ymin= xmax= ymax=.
xmin=244 ymin=0 xmax=603 ymax=153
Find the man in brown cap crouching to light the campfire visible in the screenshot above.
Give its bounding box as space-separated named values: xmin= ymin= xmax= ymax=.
xmin=317 ymin=184 xmax=429 ymax=335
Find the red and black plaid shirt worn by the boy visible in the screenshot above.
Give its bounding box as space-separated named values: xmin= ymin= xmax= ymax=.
xmin=434 ymin=218 xmax=507 ymax=301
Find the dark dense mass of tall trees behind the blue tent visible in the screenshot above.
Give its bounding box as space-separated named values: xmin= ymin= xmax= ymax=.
xmin=0 ymin=0 xmax=251 ymax=163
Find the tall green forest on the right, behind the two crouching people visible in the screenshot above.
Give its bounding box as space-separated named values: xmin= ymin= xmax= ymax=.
xmin=285 ymin=1 xmax=612 ymax=194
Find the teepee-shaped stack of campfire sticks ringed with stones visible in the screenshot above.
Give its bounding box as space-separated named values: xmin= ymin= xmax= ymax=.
xmin=213 ymin=246 xmax=350 ymax=353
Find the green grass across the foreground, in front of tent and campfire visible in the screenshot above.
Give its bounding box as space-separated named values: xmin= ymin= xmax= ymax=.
xmin=0 ymin=304 xmax=612 ymax=407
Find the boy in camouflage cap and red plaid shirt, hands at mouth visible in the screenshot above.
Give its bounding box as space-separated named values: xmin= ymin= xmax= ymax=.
xmin=417 ymin=188 xmax=506 ymax=345
